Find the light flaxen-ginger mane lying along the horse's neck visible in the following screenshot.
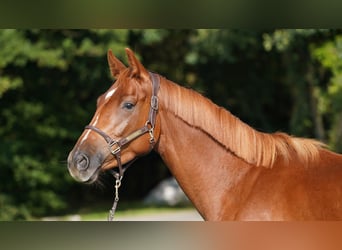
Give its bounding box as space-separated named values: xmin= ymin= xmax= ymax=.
xmin=161 ymin=78 xmax=325 ymax=168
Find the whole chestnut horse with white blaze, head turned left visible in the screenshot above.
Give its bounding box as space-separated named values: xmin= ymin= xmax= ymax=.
xmin=68 ymin=49 xmax=342 ymax=221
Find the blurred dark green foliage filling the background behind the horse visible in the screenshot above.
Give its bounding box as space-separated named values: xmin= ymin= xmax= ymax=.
xmin=0 ymin=29 xmax=342 ymax=220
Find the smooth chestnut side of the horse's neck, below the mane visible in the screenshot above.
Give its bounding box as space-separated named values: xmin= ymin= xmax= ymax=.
xmin=156 ymin=80 xmax=260 ymax=220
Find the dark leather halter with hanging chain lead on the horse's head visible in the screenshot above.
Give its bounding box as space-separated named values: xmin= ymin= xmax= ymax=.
xmin=85 ymin=72 xmax=160 ymax=220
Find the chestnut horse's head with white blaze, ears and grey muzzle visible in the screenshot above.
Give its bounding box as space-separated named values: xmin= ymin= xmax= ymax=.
xmin=68 ymin=49 xmax=159 ymax=183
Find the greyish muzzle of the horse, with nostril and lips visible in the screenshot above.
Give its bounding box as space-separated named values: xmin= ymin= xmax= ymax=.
xmin=68 ymin=150 xmax=103 ymax=183
